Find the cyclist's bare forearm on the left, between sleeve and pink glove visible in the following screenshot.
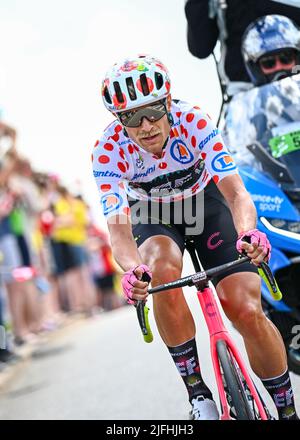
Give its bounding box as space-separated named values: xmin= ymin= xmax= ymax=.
xmin=108 ymin=225 xmax=143 ymax=272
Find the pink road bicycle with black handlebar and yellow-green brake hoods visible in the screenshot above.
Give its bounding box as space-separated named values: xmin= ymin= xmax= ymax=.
xmin=136 ymin=239 xmax=282 ymax=420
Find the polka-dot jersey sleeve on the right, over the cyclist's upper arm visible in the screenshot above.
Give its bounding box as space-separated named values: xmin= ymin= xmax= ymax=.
xmin=184 ymin=108 xmax=238 ymax=183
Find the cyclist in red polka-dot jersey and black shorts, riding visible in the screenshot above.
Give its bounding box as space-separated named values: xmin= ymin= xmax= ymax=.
xmin=93 ymin=56 xmax=297 ymax=420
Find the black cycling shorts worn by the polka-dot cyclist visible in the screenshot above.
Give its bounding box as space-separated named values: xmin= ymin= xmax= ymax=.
xmin=129 ymin=181 xmax=257 ymax=285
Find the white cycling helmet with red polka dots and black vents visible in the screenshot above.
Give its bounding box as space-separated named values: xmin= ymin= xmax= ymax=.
xmin=102 ymin=55 xmax=171 ymax=113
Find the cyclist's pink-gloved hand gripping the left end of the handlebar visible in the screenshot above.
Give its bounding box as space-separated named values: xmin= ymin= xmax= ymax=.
xmin=122 ymin=264 xmax=152 ymax=304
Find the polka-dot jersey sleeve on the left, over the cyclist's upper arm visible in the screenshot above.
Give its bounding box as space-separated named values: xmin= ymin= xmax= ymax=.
xmin=92 ymin=141 xmax=129 ymax=220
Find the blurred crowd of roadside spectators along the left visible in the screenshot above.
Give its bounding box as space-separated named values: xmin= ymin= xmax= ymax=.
xmin=0 ymin=121 xmax=124 ymax=374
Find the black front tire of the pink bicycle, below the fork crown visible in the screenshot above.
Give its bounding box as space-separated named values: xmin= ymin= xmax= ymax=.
xmin=217 ymin=340 xmax=254 ymax=420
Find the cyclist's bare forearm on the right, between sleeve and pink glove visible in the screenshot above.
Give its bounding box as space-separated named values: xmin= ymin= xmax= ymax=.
xmin=227 ymin=191 xmax=257 ymax=234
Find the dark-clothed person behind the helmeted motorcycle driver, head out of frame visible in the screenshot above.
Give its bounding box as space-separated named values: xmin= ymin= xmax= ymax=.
xmin=185 ymin=0 xmax=300 ymax=95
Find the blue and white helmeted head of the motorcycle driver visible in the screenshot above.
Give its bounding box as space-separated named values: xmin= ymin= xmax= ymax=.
xmin=242 ymin=15 xmax=300 ymax=86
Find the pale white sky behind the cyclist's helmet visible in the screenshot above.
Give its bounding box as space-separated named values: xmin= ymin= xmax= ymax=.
xmin=0 ymin=0 xmax=221 ymax=227
